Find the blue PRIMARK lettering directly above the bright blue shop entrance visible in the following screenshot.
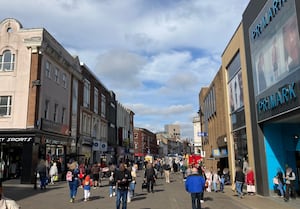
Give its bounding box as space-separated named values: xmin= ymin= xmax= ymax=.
xmin=258 ymin=82 xmax=297 ymax=113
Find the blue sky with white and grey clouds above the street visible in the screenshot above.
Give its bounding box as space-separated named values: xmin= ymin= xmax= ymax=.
xmin=0 ymin=0 xmax=249 ymax=139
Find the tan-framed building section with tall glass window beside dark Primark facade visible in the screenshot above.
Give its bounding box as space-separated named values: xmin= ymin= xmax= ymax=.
xmin=222 ymin=23 xmax=254 ymax=187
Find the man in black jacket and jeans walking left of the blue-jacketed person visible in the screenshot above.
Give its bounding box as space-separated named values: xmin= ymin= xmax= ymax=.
xmin=115 ymin=163 xmax=132 ymax=209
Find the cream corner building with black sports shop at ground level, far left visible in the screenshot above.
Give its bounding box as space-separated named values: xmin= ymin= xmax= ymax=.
xmin=0 ymin=19 xmax=81 ymax=182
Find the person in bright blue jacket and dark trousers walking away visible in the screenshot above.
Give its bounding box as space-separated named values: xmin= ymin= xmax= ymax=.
xmin=185 ymin=168 xmax=205 ymax=209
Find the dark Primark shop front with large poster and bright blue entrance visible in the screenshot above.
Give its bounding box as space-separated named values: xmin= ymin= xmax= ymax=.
xmin=243 ymin=0 xmax=300 ymax=195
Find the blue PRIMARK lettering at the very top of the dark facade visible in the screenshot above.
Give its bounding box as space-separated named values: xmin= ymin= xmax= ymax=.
xmin=252 ymin=0 xmax=287 ymax=39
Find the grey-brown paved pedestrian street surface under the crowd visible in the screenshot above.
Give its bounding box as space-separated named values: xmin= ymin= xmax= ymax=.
xmin=3 ymin=171 xmax=300 ymax=209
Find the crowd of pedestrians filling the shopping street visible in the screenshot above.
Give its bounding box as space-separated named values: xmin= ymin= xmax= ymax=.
xmin=11 ymin=159 xmax=296 ymax=209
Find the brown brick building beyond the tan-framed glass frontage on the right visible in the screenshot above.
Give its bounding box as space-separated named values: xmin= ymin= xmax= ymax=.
xmin=199 ymin=68 xmax=229 ymax=171
